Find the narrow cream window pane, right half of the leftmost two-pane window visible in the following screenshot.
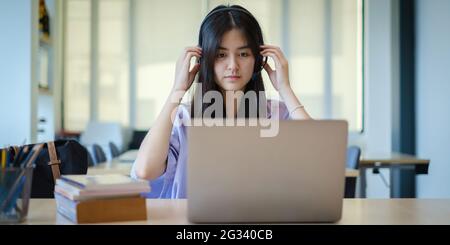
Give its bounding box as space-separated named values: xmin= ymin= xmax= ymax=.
xmin=98 ymin=0 xmax=130 ymax=126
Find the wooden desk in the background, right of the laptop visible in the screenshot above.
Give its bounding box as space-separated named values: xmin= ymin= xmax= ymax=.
xmin=359 ymin=152 xmax=430 ymax=198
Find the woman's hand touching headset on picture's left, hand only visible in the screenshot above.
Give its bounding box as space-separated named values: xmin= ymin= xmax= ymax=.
xmin=173 ymin=47 xmax=202 ymax=92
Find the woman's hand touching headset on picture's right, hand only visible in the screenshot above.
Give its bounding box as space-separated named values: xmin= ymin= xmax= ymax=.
xmin=261 ymin=45 xmax=290 ymax=92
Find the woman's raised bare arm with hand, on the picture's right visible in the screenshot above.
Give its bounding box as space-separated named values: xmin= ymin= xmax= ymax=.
xmin=261 ymin=45 xmax=312 ymax=119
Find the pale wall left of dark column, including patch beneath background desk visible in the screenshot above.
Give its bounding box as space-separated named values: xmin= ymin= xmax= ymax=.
xmin=349 ymin=0 xmax=398 ymax=198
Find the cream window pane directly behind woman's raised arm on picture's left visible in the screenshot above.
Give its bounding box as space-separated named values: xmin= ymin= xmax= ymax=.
xmin=134 ymin=0 xmax=203 ymax=129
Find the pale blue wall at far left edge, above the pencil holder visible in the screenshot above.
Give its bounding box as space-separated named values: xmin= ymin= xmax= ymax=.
xmin=0 ymin=0 xmax=38 ymax=147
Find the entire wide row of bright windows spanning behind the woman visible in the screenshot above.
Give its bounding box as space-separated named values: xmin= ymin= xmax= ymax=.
xmin=65 ymin=0 xmax=363 ymax=132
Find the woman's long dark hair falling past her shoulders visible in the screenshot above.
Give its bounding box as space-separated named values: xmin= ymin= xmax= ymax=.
xmin=191 ymin=5 xmax=267 ymax=118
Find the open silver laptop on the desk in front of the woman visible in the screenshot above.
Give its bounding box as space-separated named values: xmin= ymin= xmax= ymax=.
xmin=187 ymin=120 xmax=348 ymax=223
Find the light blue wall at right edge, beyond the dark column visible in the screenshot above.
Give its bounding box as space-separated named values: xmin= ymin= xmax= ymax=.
xmin=416 ymin=0 xmax=450 ymax=198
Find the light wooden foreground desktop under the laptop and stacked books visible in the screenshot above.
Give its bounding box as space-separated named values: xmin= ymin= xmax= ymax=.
xmin=23 ymin=199 xmax=450 ymax=225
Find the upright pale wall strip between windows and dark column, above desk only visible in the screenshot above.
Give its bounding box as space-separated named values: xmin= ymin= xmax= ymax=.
xmin=365 ymin=0 xmax=394 ymax=152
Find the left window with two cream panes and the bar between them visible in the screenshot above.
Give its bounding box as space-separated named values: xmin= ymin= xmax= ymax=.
xmin=64 ymin=0 xmax=130 ymax=131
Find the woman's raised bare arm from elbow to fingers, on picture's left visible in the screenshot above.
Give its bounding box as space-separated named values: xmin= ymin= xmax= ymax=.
xmin=135 ymin=47 xmax=201 ymax=180
